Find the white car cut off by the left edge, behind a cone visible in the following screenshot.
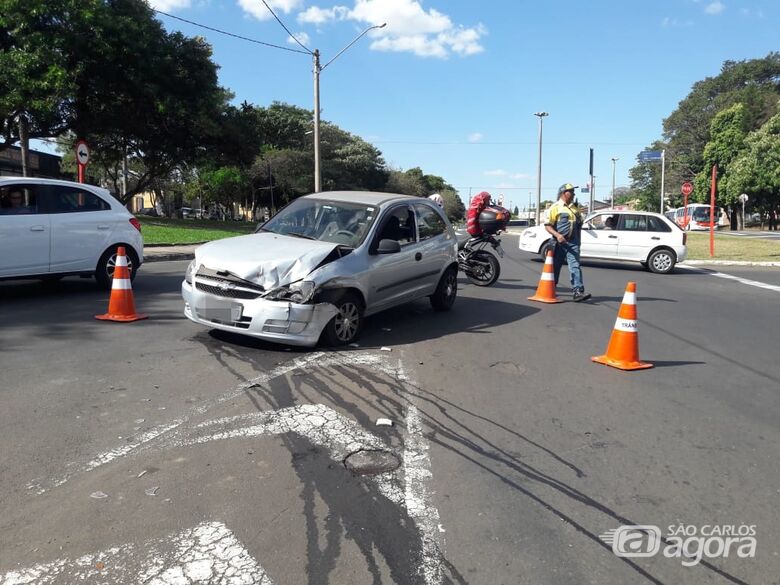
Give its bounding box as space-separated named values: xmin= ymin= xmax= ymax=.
xmin=0 ymin=177 xmax=144 ymax=288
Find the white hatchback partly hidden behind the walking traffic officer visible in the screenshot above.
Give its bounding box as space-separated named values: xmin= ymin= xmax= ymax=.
xmin=520 ymin=209 xmax=688 ymax=274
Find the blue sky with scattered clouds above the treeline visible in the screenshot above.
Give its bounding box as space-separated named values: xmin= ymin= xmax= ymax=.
xmin=150 ymin=0 xmax=780 ymax=208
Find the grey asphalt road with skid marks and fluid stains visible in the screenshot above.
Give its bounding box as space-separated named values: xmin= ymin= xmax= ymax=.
xmin=0 ymin=237 xmax=780 ymax=585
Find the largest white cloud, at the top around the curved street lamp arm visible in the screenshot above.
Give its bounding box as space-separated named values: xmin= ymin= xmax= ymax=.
xmin=294 ymin=0 xmax=487 ymax=59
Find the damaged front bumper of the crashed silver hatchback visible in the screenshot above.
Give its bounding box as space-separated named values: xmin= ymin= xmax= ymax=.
xmin=181 ymin=280 xmax=336 ymax=347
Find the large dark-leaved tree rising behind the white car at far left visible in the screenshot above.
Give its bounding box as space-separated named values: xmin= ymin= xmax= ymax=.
xmin=0 ymin=0 xmax=229 ymax=198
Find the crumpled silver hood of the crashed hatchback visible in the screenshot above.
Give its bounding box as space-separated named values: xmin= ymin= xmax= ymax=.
xmin=195 ymin=232 xmax=338 ymax=291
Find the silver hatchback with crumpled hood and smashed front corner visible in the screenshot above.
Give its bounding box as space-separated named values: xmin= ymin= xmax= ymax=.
xmin=182 ymin=191 xmax=458 ymax=346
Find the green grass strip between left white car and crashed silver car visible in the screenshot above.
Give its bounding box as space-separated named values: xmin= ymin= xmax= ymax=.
xmin=136 ymin=215 xmax=256 ymax=246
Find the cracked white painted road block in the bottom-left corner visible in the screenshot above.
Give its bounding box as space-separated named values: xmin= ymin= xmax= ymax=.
xmin=0 ymin=522 xmax=273 ymax=585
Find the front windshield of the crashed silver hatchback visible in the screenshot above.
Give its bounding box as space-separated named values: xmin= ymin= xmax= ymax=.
xmin=258 ymin=197 xmax=378 ymax=248
